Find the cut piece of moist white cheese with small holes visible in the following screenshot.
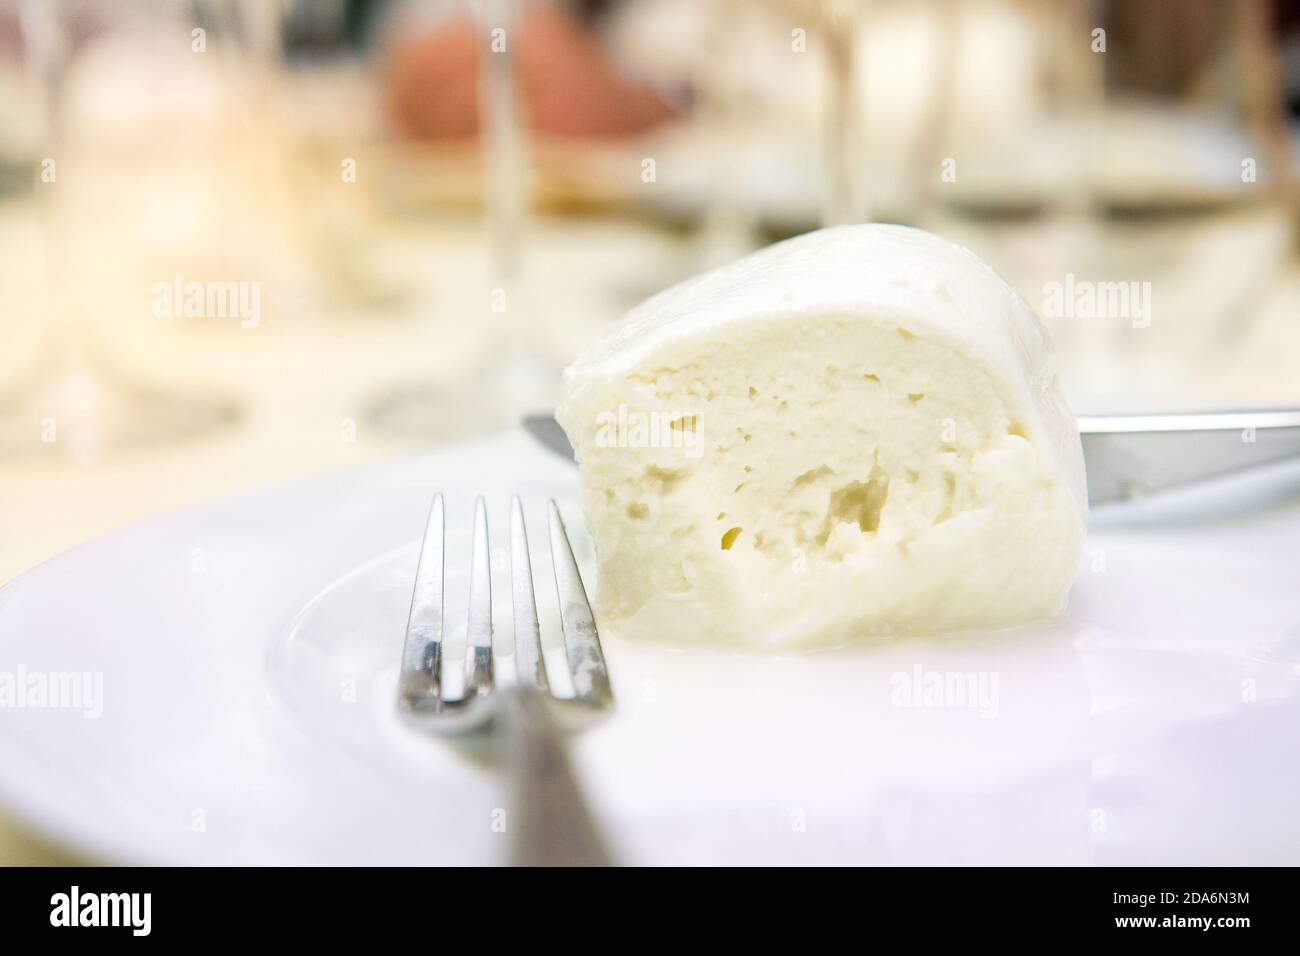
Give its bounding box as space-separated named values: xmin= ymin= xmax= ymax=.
xmin=558 ymin=225 xmax=1086 ymax=646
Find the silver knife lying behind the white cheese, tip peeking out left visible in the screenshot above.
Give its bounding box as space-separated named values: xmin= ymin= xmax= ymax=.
xmin=524 ymin=408 xmax=1300 ymax=505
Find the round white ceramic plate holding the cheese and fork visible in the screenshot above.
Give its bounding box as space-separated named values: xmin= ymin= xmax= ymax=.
xmin=0 ymin=433 xmax=1300 ymax=864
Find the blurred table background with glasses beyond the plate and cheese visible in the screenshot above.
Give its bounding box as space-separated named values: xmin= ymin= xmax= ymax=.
xmin=0 ymin=0 xmax=1300 ymax=862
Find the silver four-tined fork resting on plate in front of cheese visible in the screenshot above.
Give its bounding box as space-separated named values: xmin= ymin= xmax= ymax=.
xmin=398 ymin=494 xmax=614 ymax=866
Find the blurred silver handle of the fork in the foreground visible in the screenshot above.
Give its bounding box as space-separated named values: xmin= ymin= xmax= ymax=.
xmin=503 ymin=688 xmax=614 ymax=866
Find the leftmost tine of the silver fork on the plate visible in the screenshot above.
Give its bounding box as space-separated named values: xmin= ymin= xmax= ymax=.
xmin=399 ymin=494 xmax=445 ymax=709
